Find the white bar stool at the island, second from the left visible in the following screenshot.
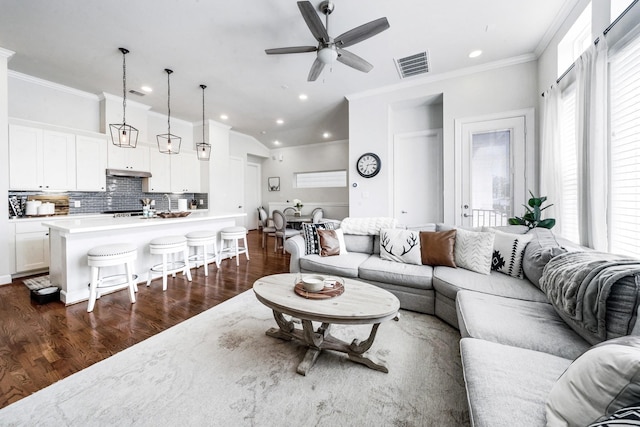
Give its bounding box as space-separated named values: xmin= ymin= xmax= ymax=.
xmin=147 ymin=236 xmax=191 ymax=291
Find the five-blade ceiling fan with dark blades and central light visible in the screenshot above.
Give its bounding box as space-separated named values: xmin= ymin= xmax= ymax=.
xmin=265 ymin=1 xmax=389 ymax=82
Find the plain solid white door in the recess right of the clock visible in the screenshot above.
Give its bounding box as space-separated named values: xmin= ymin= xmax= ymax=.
xmin=393 ymin=130 xmax=443 ymax=225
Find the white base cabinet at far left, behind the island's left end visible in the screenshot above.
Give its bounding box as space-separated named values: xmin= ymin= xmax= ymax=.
xmin=15 ymin=221 xmax=49 ymax=273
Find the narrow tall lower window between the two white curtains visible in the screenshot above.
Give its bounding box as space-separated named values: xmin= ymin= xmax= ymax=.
xmin=559 ymin=85 xmax=580 ymax=243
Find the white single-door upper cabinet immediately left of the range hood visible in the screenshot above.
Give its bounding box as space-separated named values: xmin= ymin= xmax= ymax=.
xmin=76 ymin=135 xmax=109 ymax=191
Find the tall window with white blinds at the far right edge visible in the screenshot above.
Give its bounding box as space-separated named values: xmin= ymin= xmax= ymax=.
xmin=609 ymin=37 xmax=640 ymax=256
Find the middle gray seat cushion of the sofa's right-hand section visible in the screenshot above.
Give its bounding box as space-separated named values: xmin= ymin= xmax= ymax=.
xmin=456 ymin=291 xmax=591 ymax=360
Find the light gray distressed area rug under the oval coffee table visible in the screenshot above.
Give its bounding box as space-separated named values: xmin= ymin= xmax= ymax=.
xmin=0 ymin=290 xmax=469 ymax=427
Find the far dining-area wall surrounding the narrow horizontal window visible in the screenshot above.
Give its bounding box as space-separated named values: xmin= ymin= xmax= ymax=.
xmin=262 ymin=140 xmax=349 ymax=212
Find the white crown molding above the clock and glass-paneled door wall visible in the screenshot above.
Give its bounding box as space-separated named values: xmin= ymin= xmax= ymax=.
xmin=345 ymin=53 xmax=538 ymax=101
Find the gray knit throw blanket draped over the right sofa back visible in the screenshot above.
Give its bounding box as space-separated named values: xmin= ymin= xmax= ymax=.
xmin=540 ymin=251 xmax=640 ymax=340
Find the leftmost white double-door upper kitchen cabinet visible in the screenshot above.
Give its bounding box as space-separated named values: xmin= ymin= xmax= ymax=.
xmin=9 ymin=125 xmax=76 ymax=191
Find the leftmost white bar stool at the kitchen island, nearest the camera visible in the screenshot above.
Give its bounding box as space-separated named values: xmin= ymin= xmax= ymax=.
xmin=87 ymin=243 xmax=138 ymax=313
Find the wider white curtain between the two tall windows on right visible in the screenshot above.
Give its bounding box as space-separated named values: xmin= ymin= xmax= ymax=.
xmin=575 ymin=35 xmax=609 ymax=251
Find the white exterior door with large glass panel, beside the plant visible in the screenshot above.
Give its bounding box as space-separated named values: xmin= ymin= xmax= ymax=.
xmin=459 ymin=116 xmax=526 ymax=227
